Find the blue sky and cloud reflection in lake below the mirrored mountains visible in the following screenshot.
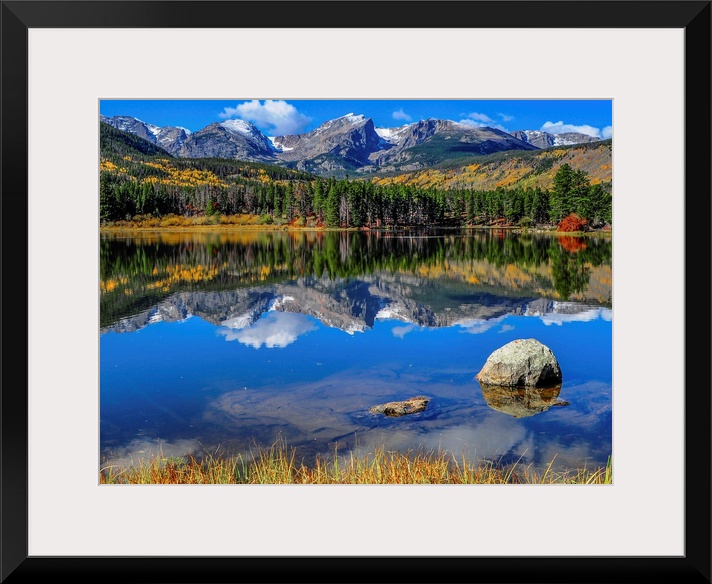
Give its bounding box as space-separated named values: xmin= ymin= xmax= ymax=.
xmin=101 ymin=296 xmax=612 ymax=474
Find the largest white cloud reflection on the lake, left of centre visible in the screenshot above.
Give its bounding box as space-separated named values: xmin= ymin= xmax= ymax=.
xmin=219 ymin=311 xmax=316 ymax=349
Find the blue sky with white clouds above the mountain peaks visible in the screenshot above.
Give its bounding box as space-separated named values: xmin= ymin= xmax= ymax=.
xmin=100 ymin=99 xmax=613 ymax=138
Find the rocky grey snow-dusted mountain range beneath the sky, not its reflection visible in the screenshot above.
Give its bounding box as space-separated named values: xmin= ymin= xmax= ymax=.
xmin=100 ymin=113 xmax=599 ymax=176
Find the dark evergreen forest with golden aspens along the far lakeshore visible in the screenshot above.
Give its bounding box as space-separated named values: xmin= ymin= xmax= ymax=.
xmin=99 ymin=123 xmax=612 ymax=229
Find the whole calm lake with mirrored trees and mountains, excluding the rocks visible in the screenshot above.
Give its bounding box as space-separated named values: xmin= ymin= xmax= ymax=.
xmin=99 ymin=230 xmax=612 ymax=470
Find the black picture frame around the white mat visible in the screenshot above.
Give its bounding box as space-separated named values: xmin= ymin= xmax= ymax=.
xmin=0 ymin=0 xmax=712 ymax=584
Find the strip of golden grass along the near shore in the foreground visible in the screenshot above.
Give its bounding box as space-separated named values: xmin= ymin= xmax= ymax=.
xmin=99 ymin=442 xmax=613 ymax=485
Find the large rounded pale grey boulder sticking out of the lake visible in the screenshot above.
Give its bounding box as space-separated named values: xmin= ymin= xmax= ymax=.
xmin=475 ymin=339 xmax=562 ymax=387
